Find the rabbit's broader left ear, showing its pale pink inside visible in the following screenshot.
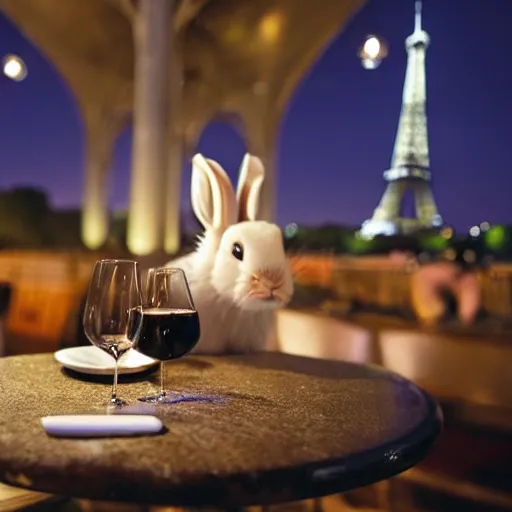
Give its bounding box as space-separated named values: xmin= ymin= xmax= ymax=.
xmin=191 ymin=154 xmax=236 ymax=229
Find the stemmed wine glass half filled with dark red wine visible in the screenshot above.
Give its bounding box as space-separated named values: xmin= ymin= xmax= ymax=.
xmin=136 ymin=267 xmax=200 ymax=403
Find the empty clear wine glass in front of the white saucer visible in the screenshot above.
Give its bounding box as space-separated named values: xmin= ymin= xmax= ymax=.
xmin=83 ymin=260 xmax=142 ymax=406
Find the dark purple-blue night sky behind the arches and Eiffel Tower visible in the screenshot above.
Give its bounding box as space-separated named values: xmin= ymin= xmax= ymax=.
xmin=0 ymin=0 xmax=512 ymax=230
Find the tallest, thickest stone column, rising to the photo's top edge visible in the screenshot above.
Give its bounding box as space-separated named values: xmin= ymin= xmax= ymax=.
xmin=127 ymin=0 xmax=172 ymax=256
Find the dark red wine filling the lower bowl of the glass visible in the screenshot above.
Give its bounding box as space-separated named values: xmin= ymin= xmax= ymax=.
xmin=135 ymin=308 xmax=200 ymax=361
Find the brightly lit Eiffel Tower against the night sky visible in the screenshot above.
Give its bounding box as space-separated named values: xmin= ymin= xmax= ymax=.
xmin=361 ymin=0 xmax=443 ymax=237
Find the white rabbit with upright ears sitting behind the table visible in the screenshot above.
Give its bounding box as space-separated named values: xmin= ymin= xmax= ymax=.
xmin=167 ymin=154 xmax=293 ymax=354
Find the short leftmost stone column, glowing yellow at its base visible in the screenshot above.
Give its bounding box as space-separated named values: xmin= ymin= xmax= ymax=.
xmin=82 ymin=111 xmax=121 ymax=250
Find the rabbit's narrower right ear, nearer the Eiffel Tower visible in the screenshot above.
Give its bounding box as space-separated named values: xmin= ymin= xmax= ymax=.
xmin=236 ymin=153 xmax=265 ymax=222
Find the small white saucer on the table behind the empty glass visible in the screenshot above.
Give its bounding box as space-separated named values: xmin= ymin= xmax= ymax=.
xmin=53 ymin=345 xmax=158 ymax=375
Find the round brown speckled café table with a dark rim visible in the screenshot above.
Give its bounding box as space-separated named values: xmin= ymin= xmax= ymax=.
xmin=0 ymin=352 xmax=442 ymax=507
